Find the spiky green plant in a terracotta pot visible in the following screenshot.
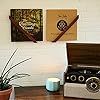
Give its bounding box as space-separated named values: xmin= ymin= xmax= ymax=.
xmin=0 ymin=49 xmax=31 ymax=100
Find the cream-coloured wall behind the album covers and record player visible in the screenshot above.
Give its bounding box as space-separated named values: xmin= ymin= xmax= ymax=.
xmin=0 ymin=0 xmax=100 ymax=86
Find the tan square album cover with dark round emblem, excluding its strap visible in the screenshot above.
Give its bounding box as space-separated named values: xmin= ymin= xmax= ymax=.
xmin=46 ymin=9 xmax=77 ymax=41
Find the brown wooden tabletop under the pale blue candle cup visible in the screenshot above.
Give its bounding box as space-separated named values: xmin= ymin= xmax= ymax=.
xmin=15 ymin=86 xmax=87 ymax=100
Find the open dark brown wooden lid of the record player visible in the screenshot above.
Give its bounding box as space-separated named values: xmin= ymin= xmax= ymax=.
xmin=66 ymin=43 xmax=100 ymax=66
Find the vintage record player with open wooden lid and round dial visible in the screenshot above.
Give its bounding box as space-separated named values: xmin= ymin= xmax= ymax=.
xmin=63 ymin=43 xmax=100 ymax=100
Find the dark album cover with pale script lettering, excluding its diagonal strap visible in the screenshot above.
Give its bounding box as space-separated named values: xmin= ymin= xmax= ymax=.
xmin=10 ymin=9 xmax=43 ymax=42
